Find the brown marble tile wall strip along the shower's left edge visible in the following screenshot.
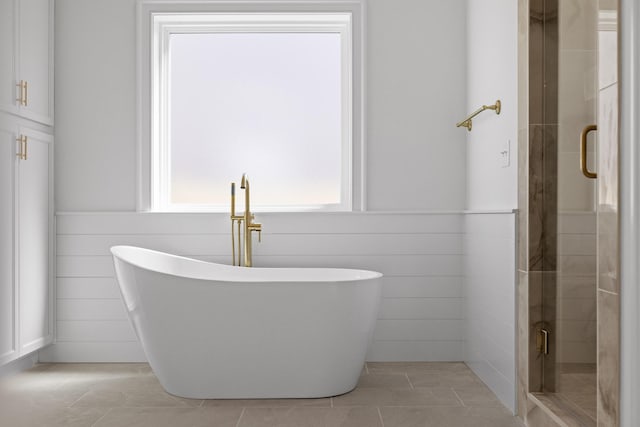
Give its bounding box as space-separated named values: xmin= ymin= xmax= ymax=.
xmin=517 ymin=0 xmax=558 ymax=425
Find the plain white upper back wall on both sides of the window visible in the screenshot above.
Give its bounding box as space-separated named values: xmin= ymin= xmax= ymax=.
xmin=55 ymin=0 xmax=466 ymax=211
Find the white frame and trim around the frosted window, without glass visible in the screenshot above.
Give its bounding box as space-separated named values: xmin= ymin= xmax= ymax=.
xmin=137 ymin=0 xmax=365 ymax=212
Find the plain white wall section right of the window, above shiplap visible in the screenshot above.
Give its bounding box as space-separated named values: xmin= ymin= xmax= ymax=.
xmin=367 ymin=0 xmax=467 ymax=210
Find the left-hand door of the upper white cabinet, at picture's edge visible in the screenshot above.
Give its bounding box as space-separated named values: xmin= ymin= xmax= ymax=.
xmin=0 ymin=0 xmax=18 ymax=113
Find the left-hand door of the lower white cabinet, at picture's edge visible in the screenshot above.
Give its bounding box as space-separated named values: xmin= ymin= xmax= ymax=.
xmin=0 ymin=123 xmax=18 ymax=365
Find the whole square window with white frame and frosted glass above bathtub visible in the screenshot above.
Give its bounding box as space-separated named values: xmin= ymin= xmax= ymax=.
xmin=139 ymin=2 xmax=362 ymax=212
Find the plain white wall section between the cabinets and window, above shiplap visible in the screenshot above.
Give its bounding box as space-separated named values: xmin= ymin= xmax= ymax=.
xmin=55 ymin=0 xmax=136 ymax=211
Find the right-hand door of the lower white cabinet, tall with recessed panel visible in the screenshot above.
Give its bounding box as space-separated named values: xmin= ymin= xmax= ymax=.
xmin=16 ymin=129 xmax=53 ymax=354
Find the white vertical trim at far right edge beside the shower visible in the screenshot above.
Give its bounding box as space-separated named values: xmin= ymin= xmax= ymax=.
xmin=619 ymin=0 xmax=640 ymax=427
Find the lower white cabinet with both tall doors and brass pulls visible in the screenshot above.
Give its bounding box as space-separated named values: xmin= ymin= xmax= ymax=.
xmin=0 ymin=115 xmax=53 ymax=364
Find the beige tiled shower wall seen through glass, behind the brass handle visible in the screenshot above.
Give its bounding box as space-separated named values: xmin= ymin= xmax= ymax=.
xmin=556 ymin=0 xmax=597 ymax=368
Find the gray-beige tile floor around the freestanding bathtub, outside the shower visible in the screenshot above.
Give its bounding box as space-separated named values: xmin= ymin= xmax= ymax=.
xmin=0 ymin=363 xmax=522 ymax=427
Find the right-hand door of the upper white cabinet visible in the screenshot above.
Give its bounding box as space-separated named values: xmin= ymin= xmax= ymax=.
xmin=16 ymin=0 xmax=53 ymax=125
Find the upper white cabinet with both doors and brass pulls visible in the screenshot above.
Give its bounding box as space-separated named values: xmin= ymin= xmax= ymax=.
xmin=0 ymin=0 xmax=53 ymax=125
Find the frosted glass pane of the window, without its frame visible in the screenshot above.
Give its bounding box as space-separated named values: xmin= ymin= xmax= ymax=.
xmin=169 ymin=33 xmax=343 ymax=210
